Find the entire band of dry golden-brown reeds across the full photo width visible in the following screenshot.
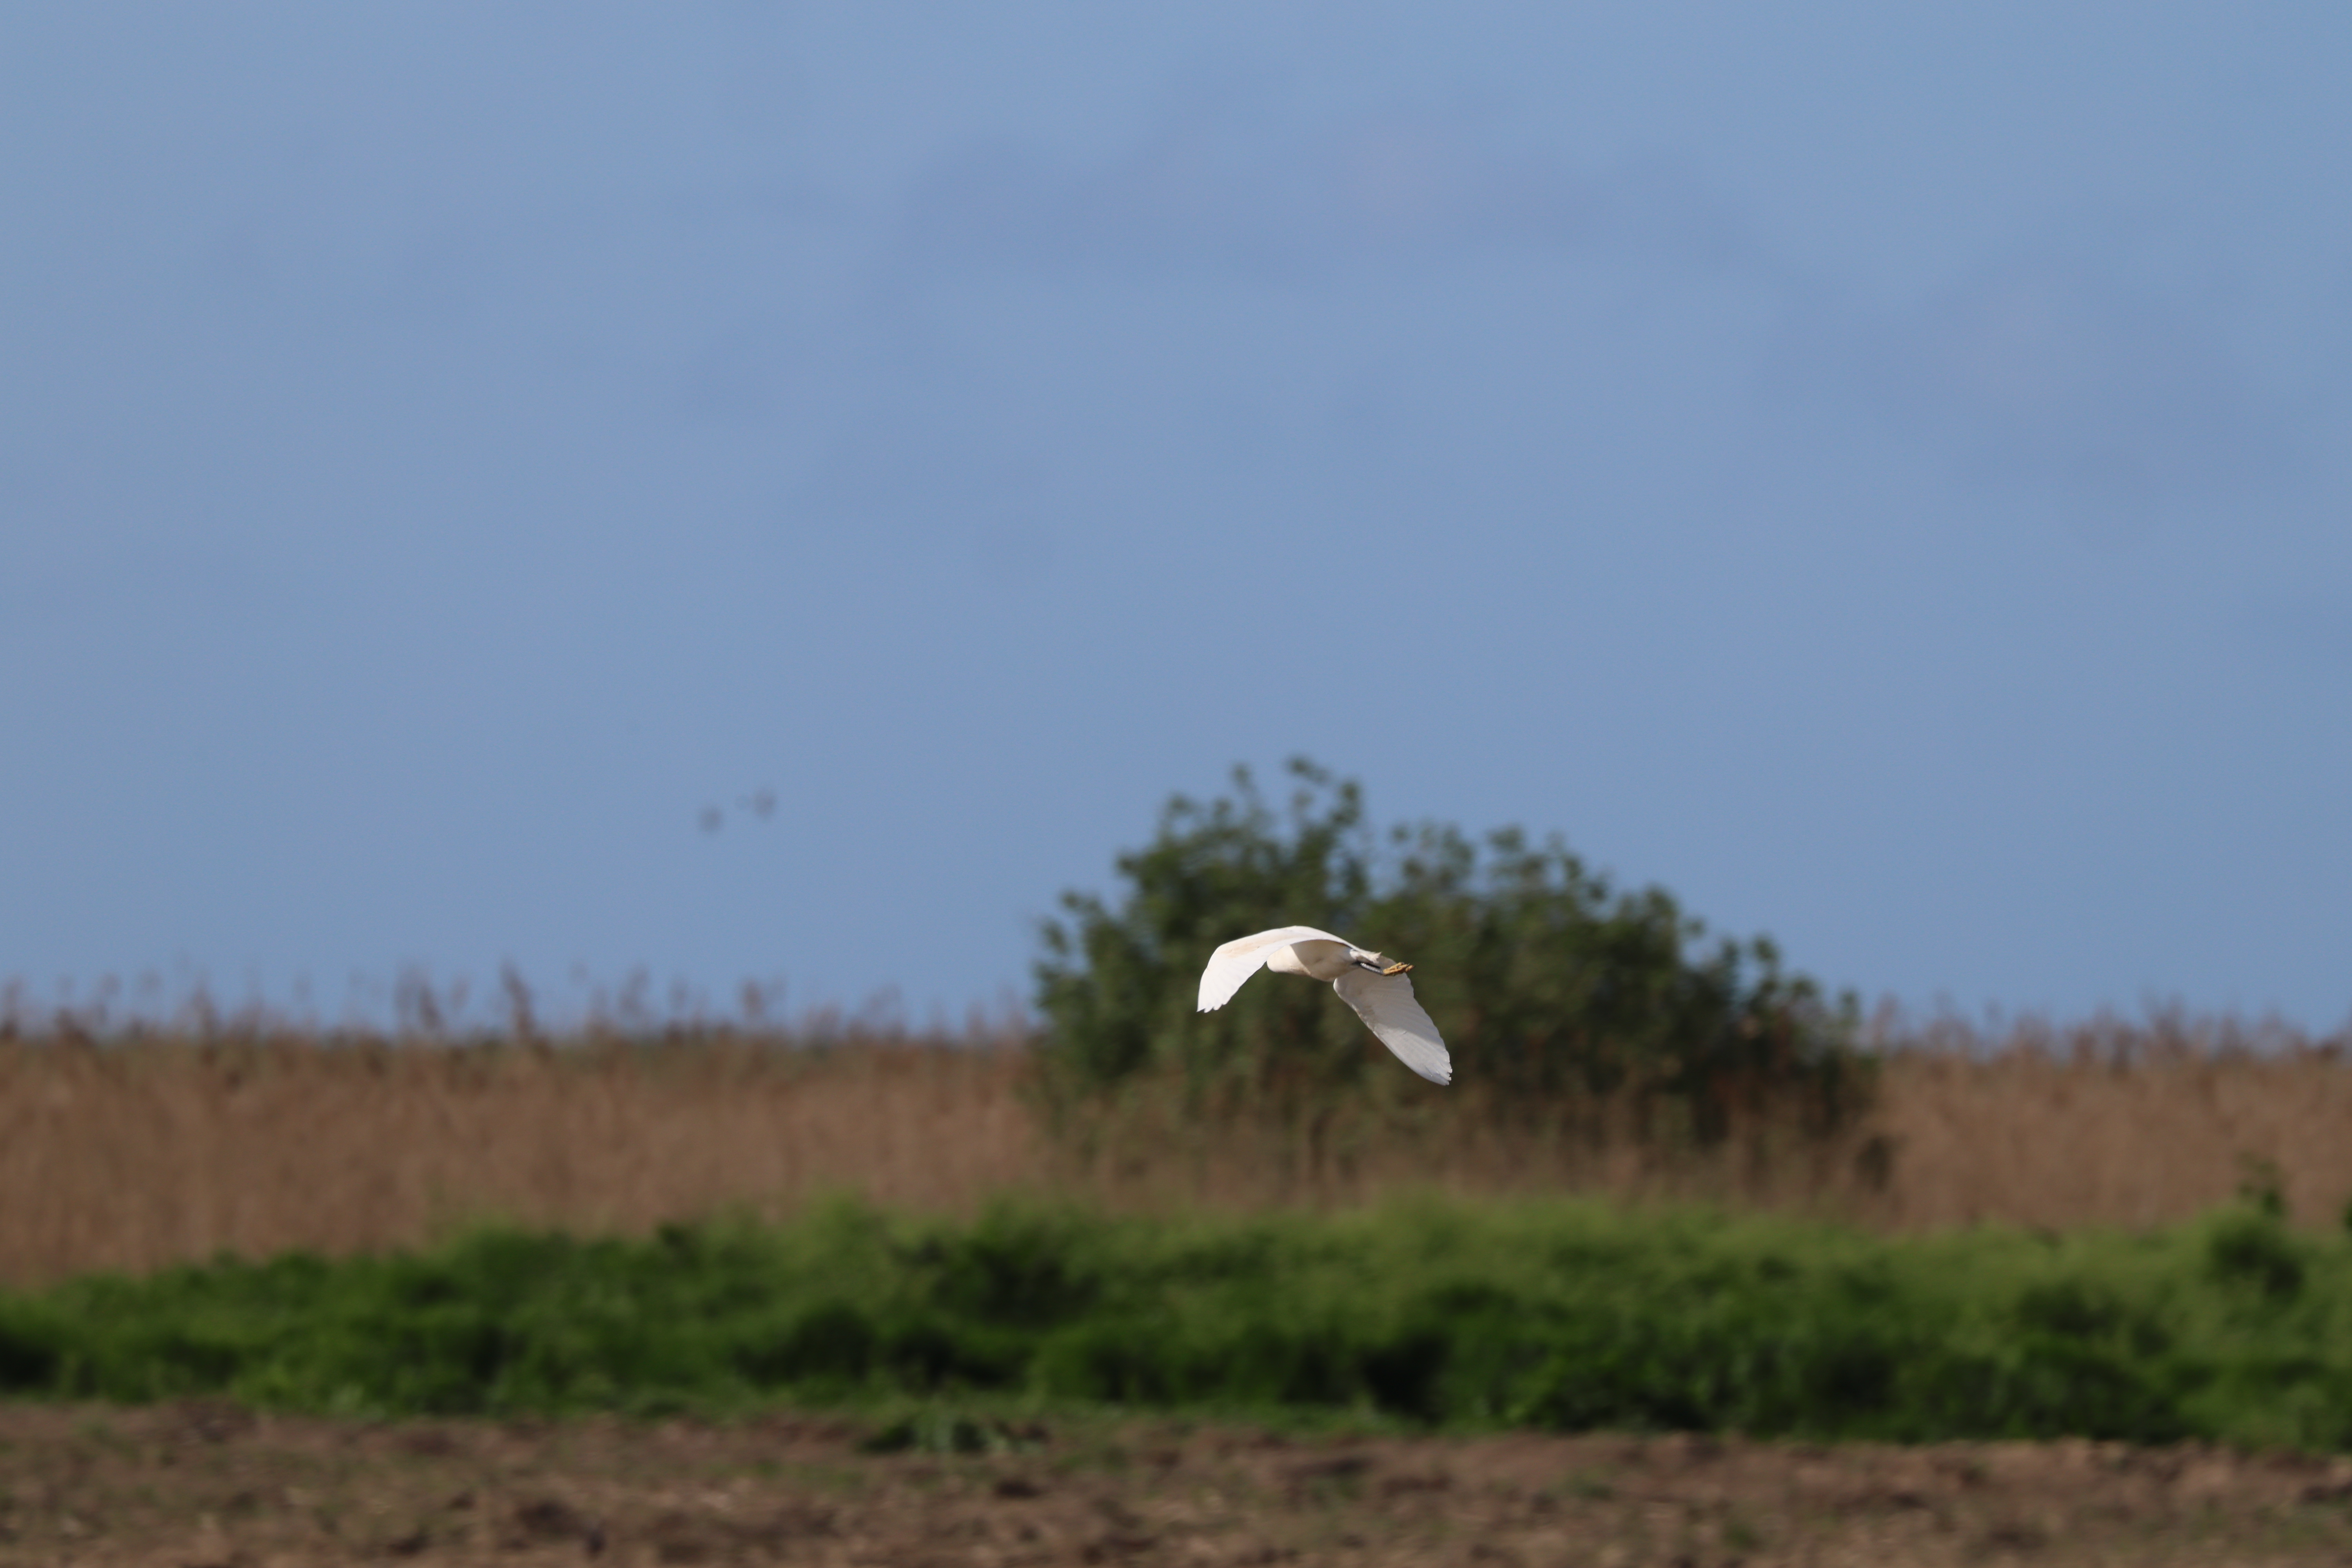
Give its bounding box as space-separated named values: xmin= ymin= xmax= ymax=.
xmin=0 ymin=1018 xmax=2352 ymax=1286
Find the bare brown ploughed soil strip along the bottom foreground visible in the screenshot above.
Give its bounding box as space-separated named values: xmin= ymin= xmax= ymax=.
xmin=0 ymin=1406 xmax=2352 ymax=1568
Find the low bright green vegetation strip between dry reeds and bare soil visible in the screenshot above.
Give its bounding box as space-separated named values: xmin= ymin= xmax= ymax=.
xmin=0 ymin=1199 xmax=2352 ymax=1448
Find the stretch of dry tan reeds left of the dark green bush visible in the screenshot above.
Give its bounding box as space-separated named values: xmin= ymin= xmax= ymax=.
xmin=0 ymin=1032 xmax=1035 ymax=1283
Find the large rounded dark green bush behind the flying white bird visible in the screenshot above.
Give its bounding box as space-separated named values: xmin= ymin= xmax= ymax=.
xmin=1037 ymin=759 xmax=1867 ymax=1143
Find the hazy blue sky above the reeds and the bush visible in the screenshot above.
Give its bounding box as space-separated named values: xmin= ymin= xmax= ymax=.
xmin=0 ymin=0 xmax=2352 ymax=1027
